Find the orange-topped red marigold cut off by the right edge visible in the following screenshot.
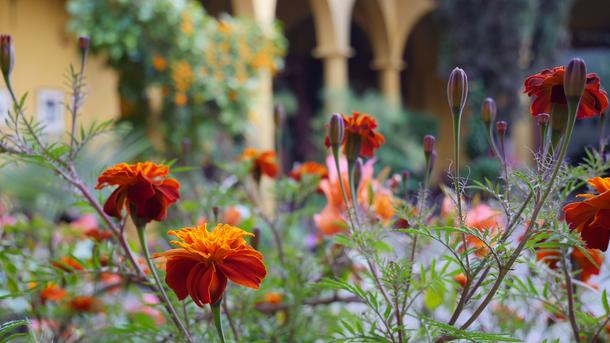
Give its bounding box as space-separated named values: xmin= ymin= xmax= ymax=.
xmin=563 ymin=177 xmax=610 ymax=251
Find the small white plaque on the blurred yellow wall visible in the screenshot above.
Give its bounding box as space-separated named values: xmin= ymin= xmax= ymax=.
xmin=37 ymin=89 xmax=65 ymax=136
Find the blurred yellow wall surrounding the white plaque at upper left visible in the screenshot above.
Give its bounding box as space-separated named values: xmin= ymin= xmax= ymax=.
xmin=0 ymin=0 xmax=119 ymax=126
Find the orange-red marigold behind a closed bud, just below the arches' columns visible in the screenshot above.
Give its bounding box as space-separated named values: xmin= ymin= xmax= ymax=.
xmin=324 ymin=112 xmax=385 ymax=157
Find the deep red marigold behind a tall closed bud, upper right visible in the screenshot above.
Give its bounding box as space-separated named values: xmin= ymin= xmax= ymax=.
xmin=524 ymin=66 xmax=608 ymax=118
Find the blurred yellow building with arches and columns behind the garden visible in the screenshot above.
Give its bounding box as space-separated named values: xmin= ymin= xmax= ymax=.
xmin=0 ymin=0 xmax=610 ymax=181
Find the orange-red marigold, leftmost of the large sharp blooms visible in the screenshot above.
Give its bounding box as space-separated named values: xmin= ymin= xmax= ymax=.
xmin=95 ymin=162 xmax=180 ymax=222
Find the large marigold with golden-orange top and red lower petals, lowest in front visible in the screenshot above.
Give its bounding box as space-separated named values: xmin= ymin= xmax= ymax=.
xmin=154 ymin=224 xmax=267 ymax=307
